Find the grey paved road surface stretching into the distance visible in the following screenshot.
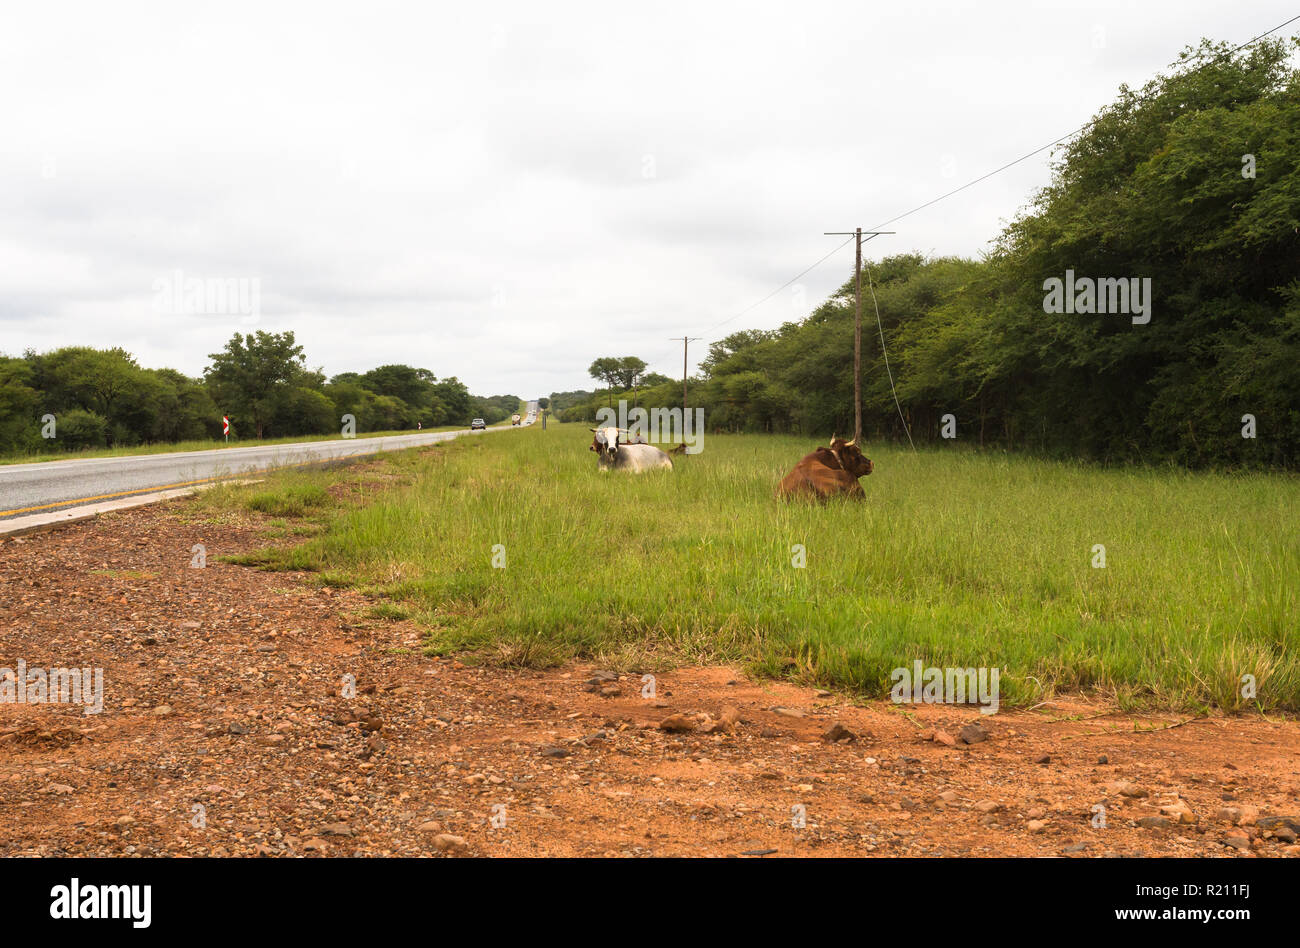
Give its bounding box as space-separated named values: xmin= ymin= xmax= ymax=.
xmin=0 ymin=425 xmax=510 ymax=521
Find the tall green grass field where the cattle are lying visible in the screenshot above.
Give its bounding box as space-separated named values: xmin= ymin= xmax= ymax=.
xmin=239 ymin=425 xmax=1300 ymax=710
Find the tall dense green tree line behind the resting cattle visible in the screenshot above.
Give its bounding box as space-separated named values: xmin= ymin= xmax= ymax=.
xmin=553 ymin=39 xmax=1300 ymax=467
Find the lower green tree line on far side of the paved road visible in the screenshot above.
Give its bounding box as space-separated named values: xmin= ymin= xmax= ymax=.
xmin=0 ymin=330 xmax=520 ymax=454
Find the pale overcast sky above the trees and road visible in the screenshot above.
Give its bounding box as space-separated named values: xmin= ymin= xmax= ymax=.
xmin=0 ymin=0 xmax=1279 ymax=397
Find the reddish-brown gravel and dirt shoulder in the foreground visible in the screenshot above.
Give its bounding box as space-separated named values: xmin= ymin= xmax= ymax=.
xmin=0 ymin=473 xmax=1300 ymax=858
